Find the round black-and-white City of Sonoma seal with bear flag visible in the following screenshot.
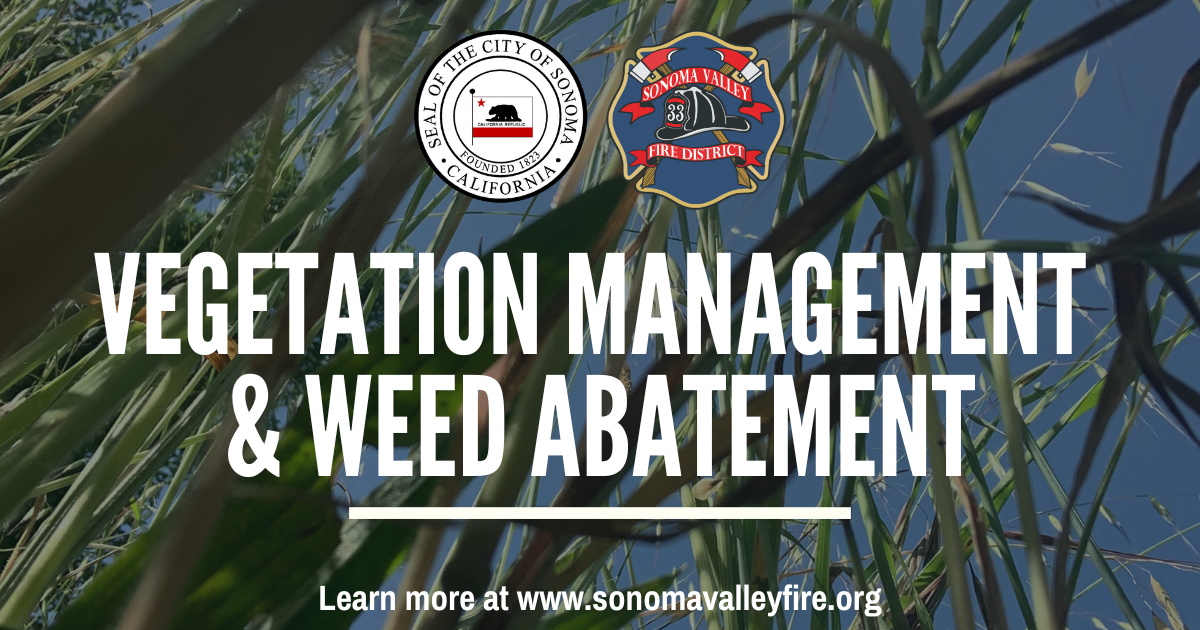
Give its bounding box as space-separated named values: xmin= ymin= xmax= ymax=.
xmin=415 ymin=31 xmax=587 ymax=202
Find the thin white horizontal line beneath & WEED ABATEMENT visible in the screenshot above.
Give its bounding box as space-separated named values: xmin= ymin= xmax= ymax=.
xmin=350 ymin=508 xmax=852 ymax=521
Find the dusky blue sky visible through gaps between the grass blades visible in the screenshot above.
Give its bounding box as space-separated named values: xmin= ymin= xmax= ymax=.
xmin=278 ymin=0 xmax=1200 ymax=630
